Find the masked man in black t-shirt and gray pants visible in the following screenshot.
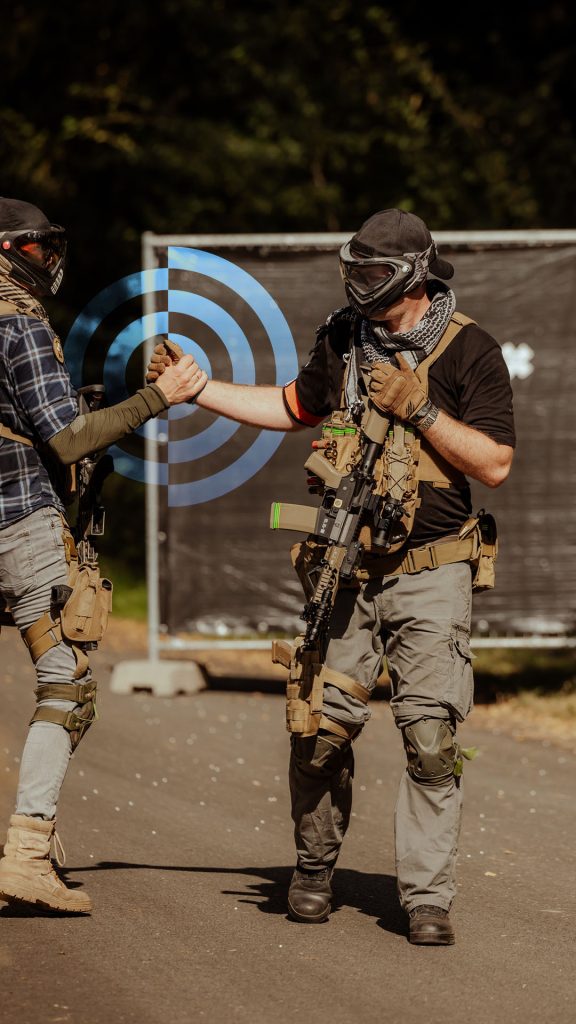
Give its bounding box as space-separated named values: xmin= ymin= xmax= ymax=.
xmin=148 ymin=210 xmax=516 ymax=945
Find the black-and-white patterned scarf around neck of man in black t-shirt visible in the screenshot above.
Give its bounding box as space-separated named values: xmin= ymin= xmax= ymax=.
xmin=345 ymin=282 xmax=456 ymax=415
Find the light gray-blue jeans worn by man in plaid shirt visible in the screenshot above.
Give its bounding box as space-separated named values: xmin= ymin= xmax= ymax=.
xmin=0 ymin=508 xmax=90 ymax=820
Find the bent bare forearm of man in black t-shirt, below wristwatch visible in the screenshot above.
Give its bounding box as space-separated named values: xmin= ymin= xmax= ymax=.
xmin=424 ymin=411 xmax=513 ymax=487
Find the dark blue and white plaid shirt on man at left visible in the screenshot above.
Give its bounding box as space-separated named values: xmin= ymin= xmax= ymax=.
xmin=0 ymin=314 xmax=78 ymax=528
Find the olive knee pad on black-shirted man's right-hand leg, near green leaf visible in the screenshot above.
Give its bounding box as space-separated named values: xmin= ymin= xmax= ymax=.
xmin=402 ymin=718 xmax=457 ymax=785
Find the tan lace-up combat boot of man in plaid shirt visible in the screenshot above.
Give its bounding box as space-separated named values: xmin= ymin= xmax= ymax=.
xmin=0 ymin=814 xmax=92 ymax=913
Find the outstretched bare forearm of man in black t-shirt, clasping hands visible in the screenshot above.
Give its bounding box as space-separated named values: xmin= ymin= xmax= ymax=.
xmin=197 ymin=381 xmax=299 ymax=430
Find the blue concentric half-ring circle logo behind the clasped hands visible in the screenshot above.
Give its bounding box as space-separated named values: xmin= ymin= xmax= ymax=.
xmin=65 ymin=246 xmax=298 ymax=507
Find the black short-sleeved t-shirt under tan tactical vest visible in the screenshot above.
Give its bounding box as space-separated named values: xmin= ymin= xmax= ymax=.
xmin=285 ymin=311 xmax=516 ymax=547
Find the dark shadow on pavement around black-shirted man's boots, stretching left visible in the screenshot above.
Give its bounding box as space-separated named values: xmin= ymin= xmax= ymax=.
xmin=63 ymin=860 xmax=408 ymax=936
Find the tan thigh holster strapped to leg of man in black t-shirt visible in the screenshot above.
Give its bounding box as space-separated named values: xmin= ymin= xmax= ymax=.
xmin=272 ymin=637 xmax=369 ymax=739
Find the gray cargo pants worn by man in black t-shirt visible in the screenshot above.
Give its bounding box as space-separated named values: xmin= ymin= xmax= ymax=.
xmin=290 ymin=562 xmax=474 ymax=911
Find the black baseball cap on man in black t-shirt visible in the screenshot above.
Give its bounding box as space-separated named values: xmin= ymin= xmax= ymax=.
xmin=349 ymin=210 xmax=454 ymax=281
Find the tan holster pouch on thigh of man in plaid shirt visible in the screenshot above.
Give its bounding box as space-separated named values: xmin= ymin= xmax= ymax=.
xmin=60 ymin=562 xmax=113 ymax=643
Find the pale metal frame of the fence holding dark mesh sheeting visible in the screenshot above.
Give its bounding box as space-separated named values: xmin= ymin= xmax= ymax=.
xmin=141 ymin=228 xmax=576 ymax=662
